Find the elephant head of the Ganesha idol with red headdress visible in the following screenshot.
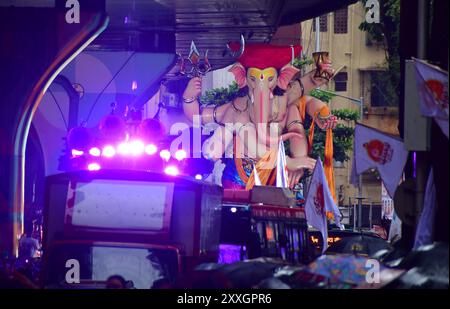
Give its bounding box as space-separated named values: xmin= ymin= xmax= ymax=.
xmin=227 ymin=39 xmax=301 ymax=143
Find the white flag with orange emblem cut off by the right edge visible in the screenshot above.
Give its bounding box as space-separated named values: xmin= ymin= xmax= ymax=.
xmin=413 ymin=58 xmax=448 ymax=138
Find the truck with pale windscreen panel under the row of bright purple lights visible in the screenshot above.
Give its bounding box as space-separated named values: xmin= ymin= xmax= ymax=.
xmin=42 ymin=170 xmax=222 ymax=288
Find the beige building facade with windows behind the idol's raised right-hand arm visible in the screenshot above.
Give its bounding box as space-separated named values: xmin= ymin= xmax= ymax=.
xmin=301 ymin=2 xmax=398 ymax=205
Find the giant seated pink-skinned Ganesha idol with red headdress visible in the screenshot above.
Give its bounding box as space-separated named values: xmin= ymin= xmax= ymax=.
xmin=183 ymin=40 xmax=336 ymax=189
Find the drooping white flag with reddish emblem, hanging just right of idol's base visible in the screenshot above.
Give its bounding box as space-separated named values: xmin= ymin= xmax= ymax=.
xmin=305 ymin=158 xmax=343 ymax=252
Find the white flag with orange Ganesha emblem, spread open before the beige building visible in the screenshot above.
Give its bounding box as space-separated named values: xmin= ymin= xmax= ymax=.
xmin=352 ymin=123 xmax=408 ymax=198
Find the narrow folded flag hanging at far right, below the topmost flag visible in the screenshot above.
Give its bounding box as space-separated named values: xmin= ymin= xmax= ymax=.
xmin=414 ymin=169 xmax=436 ymax=249
